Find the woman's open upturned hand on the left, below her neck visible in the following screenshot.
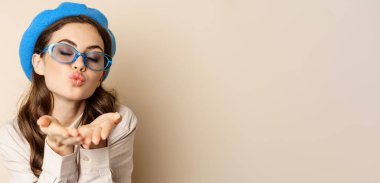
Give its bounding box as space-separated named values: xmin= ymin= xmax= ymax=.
xmin=37 ymin=115 xmax=83 ymax=156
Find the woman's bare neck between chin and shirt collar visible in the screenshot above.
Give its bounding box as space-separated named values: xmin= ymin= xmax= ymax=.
xmin=52 ymin=96 xmax=85 ymax=127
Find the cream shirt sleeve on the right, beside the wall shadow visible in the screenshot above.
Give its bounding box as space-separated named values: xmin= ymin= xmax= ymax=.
xmin=78 ymin=106 xmax=137 ymax=183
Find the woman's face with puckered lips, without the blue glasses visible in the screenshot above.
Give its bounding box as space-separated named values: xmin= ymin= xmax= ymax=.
xmin=33 ymin=23 xmax=104 ymax=101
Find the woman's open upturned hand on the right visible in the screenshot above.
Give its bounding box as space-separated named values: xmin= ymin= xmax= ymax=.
xmin=78 ymin=112 xmax=121 ymax=149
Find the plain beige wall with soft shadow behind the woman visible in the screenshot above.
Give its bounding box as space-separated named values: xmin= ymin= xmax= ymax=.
xmin=0 ymin=0 xmax=380 ymax=183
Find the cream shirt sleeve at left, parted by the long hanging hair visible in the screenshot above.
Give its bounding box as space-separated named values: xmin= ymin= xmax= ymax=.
xmin=0 ymin=123 xmax=78 ymax=183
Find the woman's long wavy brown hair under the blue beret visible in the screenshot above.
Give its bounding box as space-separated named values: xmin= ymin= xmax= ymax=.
xmin=17 ymin=15 xmax=118 ymax=177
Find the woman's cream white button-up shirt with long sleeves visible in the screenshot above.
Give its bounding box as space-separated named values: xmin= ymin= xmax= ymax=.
xmin=0 ymin=105 xmax=137 ymax=183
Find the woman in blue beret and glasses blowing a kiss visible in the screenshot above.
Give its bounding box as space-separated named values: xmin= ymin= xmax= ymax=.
xmin=0 ymin=3 xmax=137 ymax=183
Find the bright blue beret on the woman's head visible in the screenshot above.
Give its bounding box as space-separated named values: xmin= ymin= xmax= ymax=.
xmin=19 ymin=2 xmax=116 ymax=80
